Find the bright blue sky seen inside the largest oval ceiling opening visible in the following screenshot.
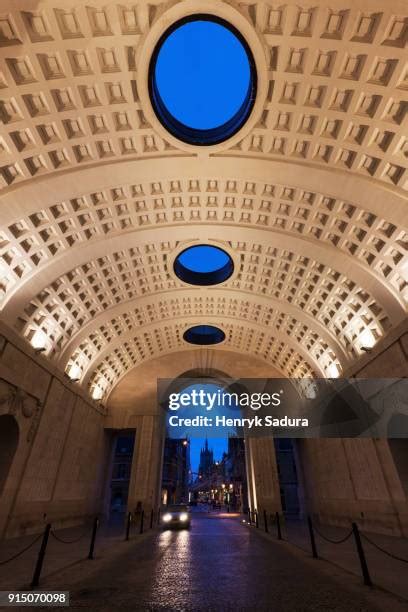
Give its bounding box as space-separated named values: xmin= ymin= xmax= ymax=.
xmin=155 ymin=21 xmax=250 ymax=130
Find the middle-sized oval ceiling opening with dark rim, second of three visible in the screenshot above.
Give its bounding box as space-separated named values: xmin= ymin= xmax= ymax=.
xmin=174 ymin=244 xmax=234 ymax=285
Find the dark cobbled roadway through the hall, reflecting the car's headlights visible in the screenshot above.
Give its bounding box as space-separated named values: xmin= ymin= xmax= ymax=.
xmin=1 ymin=515 xmax=407 ymax=612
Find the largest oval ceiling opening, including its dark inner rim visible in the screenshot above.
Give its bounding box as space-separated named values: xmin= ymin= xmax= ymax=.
xmin=149 ymin=15 xmax=256 ymax=145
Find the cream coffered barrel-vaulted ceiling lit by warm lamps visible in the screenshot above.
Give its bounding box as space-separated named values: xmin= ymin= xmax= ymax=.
xmin=0 ymin=0 xmax=408 ymax=399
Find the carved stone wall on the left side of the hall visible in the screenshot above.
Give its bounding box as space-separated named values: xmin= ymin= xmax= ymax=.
xmin=0 ymin=322 xmax=106 ymax=537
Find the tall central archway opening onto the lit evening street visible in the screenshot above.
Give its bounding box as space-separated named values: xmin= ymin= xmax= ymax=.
xmin=161 ymin=369 xmax=248 ymax=513
